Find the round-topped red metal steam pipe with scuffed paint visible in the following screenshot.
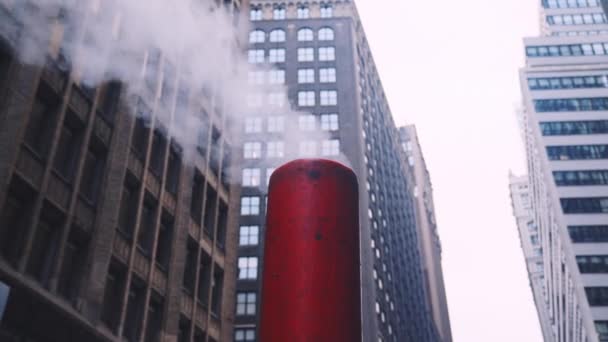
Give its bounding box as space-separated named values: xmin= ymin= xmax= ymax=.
xmin=260 ymin=159 xmax=361 ymax=342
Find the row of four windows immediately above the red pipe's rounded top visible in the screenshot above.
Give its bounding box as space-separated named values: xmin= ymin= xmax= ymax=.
xmin=243 ymin=139 xmax=340 ymax=159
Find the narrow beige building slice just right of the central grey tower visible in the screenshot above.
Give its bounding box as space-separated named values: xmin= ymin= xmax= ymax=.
xmin=399 ymin=125 xmax=452 ymax=342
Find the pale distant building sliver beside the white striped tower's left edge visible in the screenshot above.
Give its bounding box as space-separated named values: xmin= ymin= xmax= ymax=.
xmin=509 ymin=174 xmax=555 ymax=342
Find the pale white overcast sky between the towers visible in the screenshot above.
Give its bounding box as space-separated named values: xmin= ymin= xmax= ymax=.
xmin=356 ymin=0 xmax=542 ymax=342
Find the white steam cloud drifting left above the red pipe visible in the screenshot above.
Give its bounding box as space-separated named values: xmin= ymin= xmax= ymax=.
xmin=8 ymin=0 xmax=346 ymax=179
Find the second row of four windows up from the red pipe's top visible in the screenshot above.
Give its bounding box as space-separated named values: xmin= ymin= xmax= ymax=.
xmin=245 ymin=114 xmax=340 ymax=133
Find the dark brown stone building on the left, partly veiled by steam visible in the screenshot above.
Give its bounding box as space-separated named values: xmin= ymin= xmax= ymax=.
xmin=0 ymin=0 xmax=248 ymax=342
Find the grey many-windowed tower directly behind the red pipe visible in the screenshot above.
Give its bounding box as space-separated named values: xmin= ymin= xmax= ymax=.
xmin=234 ymin=1 xmax=440 ymax=342
